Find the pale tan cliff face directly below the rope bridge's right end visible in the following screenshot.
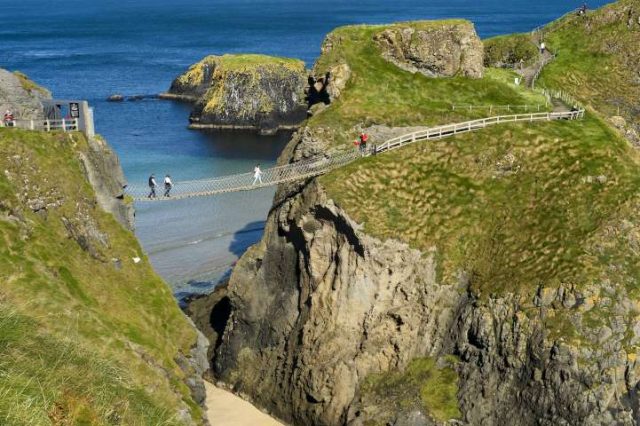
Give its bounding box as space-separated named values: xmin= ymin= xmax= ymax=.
xmin=215 ymin=177 xmax=457 ymax=424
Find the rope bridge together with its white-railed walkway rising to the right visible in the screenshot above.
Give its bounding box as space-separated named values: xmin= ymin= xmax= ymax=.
xmin=125 ymin=109 xmax=584 ymax=201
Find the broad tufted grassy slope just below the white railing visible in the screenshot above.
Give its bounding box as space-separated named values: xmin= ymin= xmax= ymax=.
xmin=320 ymin=117 xmax=640 ymax=295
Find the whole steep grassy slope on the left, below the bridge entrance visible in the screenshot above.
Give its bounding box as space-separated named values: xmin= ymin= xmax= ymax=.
xmin=0 ymin=129 xmax=199 ymax=425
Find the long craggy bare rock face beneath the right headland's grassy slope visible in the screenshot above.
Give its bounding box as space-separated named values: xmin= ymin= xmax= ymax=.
xmin=214 ymin=120 xmax=640 ymax=425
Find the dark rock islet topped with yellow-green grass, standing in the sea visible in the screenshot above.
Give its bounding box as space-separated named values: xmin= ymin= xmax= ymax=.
xmin=169 ymin=54 xmax=307 ymax=131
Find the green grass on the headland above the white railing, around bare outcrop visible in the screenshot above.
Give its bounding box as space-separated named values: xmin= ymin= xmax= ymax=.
xmin=308 ymin=21 xmax=545 ymax=147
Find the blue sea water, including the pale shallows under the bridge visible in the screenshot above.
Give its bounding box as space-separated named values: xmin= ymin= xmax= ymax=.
xmin=0 ymin=0 xmax=607 ymax=293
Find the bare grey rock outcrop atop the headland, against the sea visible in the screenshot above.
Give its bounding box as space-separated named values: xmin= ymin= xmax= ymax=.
xmin=374 ymin=21 xmax=484 ymax=78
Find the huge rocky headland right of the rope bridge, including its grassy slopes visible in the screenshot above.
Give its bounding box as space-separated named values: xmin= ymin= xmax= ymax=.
xmin=192 ymin=9 xmax=640 ymax=426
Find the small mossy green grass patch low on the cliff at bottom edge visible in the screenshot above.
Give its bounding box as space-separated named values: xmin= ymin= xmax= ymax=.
xmin=362 ymin=357 xmax=461 ymax=425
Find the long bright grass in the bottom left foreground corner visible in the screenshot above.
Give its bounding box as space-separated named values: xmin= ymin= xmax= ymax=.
xmin=0 ymin=302 xmax=178 ymax=426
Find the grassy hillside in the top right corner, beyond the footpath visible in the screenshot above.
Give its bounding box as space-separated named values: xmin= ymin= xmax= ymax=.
xmin=539 ymin=0 xmax=640 ymax=124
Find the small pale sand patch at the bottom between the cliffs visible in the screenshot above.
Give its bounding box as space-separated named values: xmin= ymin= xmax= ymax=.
xmin=204 ymin=381 xmax=283 ymax=426
